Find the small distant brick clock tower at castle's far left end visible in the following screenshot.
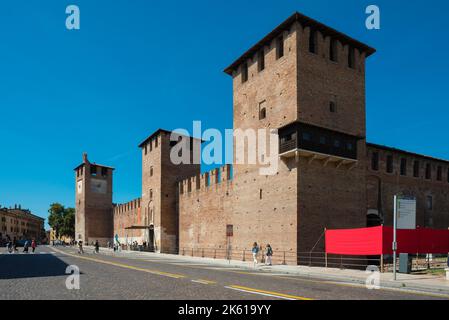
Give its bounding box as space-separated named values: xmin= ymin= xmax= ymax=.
xmin=75 ymin=154 xmax=114 ymax=246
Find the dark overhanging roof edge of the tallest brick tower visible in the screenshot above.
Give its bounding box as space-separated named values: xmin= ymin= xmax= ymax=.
xmin=224 ymin=11 xmax=376 ymax=75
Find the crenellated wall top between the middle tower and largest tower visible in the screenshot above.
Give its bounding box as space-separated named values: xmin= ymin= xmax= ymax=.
xmin=178 ymin=164 xmax=232 ymax=196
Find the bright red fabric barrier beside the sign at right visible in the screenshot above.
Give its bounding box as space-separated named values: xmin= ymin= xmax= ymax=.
xmin=326 ymin=227 xmax=449 ymax=256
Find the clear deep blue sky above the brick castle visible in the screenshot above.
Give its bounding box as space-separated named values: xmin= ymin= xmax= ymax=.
xmin=0 ymin=0 xmax=449 ymax=229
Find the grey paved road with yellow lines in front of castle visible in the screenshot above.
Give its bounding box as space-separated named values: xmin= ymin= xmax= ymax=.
xmin=0 ymin=246 xmax=449 ymax=300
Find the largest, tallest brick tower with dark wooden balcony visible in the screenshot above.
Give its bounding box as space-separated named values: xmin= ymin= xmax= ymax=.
xmin=225 ymin=13 xmax=375 ymax=253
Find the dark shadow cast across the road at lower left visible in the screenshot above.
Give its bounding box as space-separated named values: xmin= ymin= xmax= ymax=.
xmin=0 ymin=254 xmax=73 ymax=280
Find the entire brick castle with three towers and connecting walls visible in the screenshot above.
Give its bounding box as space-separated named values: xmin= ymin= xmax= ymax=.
xmin=75 ymin=13 xmax=449 ymax=263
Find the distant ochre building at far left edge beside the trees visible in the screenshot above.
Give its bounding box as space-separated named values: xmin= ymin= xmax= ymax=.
xmin=0 ymin=205 xmax=46 ymax=241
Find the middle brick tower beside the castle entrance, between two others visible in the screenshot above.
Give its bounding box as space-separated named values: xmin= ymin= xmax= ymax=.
xmin=139 ymin=129 xmax=200 ymax=253
